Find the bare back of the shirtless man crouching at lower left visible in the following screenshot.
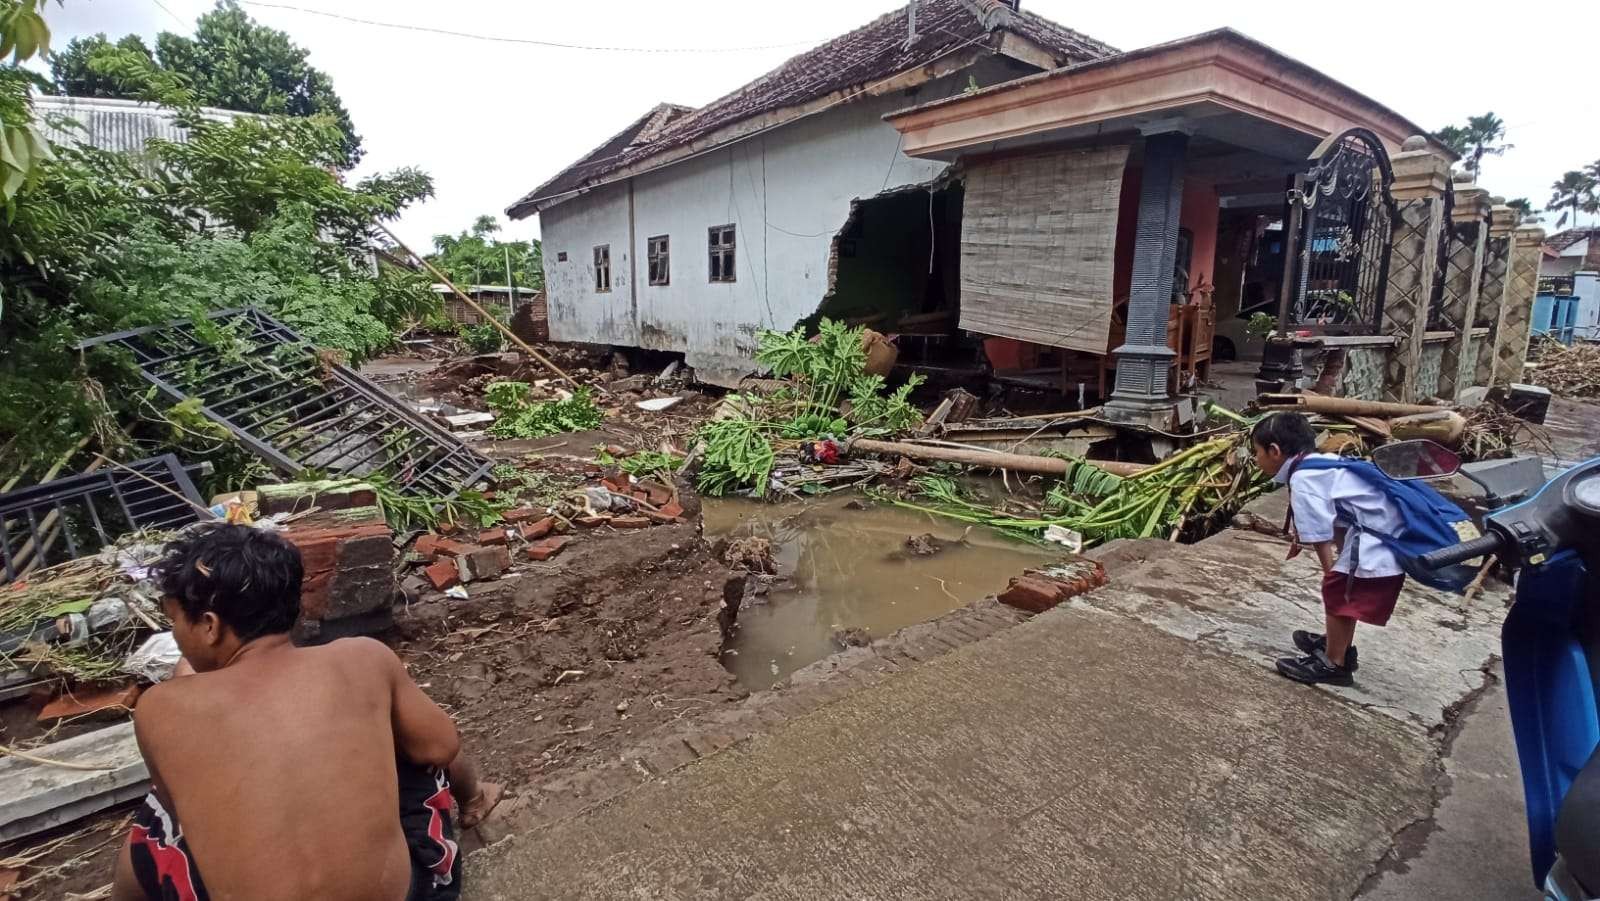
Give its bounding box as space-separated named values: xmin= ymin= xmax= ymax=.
xmin=136 ymin=637 xmax=454 ymax=901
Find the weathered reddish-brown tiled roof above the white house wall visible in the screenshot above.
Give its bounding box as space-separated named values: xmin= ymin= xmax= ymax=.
xmin=507 ymin=0 xmax=1117 ymax=218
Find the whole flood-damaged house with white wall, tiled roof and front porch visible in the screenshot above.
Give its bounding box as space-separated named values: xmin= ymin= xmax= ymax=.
xmin=509 ymin=0 xmax=1472 ymax=412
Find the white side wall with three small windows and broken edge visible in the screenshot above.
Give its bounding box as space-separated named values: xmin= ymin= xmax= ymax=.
xmin=541 ymin=61 xmax=1016 ymax=384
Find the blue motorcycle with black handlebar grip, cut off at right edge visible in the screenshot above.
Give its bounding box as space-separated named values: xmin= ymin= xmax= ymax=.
xmin=1373 ymin=440 xmax=1600 ymax=901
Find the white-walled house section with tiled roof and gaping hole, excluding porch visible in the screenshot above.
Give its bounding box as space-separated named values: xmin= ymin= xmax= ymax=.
xmin=507 ymin=0 xmax=1114 ymax=382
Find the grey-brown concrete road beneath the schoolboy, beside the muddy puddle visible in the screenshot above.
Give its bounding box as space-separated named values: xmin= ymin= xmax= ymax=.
xmin=466 ymin=492 xmax=1522 ymax=901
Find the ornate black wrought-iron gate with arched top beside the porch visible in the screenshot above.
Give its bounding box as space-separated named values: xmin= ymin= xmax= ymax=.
xmin=1280 ymin=128 xmax=1397 ymax=334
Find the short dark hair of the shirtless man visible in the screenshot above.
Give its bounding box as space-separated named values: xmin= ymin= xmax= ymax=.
xmin=154 ymin=525 xmax=306 ymax=642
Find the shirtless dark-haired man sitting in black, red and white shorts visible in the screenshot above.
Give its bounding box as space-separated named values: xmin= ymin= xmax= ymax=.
xmin=112 ymin=525 xmax=499 ymax=901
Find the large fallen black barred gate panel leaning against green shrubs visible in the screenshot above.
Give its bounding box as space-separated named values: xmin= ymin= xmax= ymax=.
xmin=78 ymin=307 xmax=490 ymax=498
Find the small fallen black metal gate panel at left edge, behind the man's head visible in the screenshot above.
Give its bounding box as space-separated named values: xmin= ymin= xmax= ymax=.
xmin=0 ymin=455 xmax=205 ymax=584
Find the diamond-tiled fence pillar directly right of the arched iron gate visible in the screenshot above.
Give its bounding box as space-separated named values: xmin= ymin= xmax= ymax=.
xmin=1381 ymin=136 xmax=1450 ymax=403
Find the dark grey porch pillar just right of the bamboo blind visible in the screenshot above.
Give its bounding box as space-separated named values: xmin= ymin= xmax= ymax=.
xmin=1104 ymin=122 xmax=1189 ymax=427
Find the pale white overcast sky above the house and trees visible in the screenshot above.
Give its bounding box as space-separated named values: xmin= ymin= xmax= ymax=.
xmin=46 ymin=0 xmax=1600 ymax=243
